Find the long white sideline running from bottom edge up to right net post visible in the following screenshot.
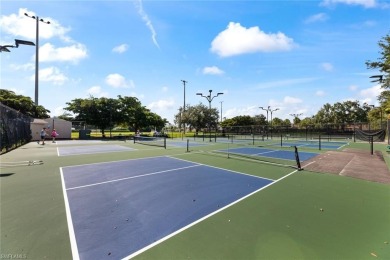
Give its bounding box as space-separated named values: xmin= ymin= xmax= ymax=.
xmin=122 ymin=170 xmax=298 ymax=260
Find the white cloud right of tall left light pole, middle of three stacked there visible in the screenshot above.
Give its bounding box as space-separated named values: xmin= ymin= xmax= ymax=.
xmin=39 ymin=43 xmax=87 ymax=64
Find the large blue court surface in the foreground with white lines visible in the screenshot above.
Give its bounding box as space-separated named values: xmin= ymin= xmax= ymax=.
xmin=61 ymin=157 xmax=273 ymax=259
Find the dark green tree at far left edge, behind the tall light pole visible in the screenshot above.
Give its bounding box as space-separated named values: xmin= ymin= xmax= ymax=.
xmin=0 ymin=89 xmax=50 ymax=118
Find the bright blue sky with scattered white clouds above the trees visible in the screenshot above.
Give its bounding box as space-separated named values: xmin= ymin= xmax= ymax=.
xmin=0 ymin=0 xmax=390 ymax=123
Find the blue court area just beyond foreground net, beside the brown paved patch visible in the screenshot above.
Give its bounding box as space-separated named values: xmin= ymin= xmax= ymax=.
xmin=218 ymin=147 xmax=318 ymax=161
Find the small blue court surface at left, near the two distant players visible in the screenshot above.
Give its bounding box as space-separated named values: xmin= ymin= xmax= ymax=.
xmin=57 ymin=145 xmax=135 ymax=156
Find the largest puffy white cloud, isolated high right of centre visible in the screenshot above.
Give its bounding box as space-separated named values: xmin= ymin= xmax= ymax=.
xmin=211 ymin=22 xmax=294 ymax=57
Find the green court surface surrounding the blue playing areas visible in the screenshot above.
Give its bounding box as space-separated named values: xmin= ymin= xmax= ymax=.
xmin=0 ymin=141 xmax=390 ymax=259
